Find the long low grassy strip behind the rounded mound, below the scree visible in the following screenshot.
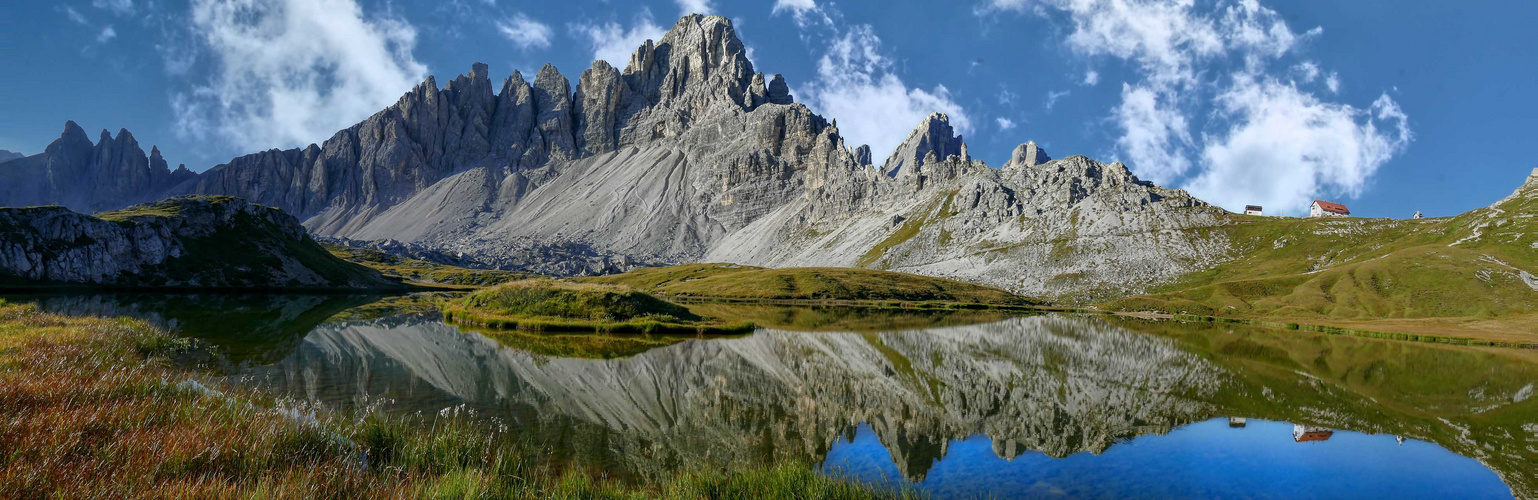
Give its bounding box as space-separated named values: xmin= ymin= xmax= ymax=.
xmin=577 ymin=263 xmax=1043 ymax=308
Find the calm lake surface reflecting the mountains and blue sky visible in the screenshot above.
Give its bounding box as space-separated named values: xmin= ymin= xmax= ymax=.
xmin=5 ymin=295 xmax=1538 ymax=498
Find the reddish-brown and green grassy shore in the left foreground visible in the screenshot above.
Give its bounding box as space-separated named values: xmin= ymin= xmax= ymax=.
xmin=0 ymin=302 xmax=912 ymax=498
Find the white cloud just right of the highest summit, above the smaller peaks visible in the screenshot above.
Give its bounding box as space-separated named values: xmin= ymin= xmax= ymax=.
xmin=803 ymin=25 xmax=972 ymax=157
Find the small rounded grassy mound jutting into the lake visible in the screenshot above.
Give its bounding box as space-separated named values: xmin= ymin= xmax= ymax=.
xmin=443 ymin=278 xmax=754 ymax=334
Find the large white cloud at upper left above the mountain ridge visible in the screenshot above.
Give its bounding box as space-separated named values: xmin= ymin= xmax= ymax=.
xmin=171 ymin=0 xmax=426 ymax=149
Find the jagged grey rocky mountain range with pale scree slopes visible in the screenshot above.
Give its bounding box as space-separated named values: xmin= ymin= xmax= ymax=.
xmin=0 ymin=15 xmax=1229 ymax=298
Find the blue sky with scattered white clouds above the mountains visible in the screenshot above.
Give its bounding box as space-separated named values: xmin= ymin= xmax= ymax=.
xmin=0 ymin=0 xmax=1538 ymax=217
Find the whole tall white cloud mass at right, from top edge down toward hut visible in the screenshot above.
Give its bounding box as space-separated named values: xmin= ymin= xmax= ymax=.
xmin=977 ymin=0 xmax=1410 ymax=212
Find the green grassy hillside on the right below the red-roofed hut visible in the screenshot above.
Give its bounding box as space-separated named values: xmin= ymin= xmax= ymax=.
xmin=1103 ymin=171 xmax=1538 ymax=337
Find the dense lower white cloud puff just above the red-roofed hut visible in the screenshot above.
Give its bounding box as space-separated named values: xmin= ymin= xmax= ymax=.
xmin=1189 ymin=75 xmax=1410 ymax=214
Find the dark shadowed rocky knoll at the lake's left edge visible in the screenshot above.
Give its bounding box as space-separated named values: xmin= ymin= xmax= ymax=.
xmin=0 ymin=197 xmax=395 ymax=288
